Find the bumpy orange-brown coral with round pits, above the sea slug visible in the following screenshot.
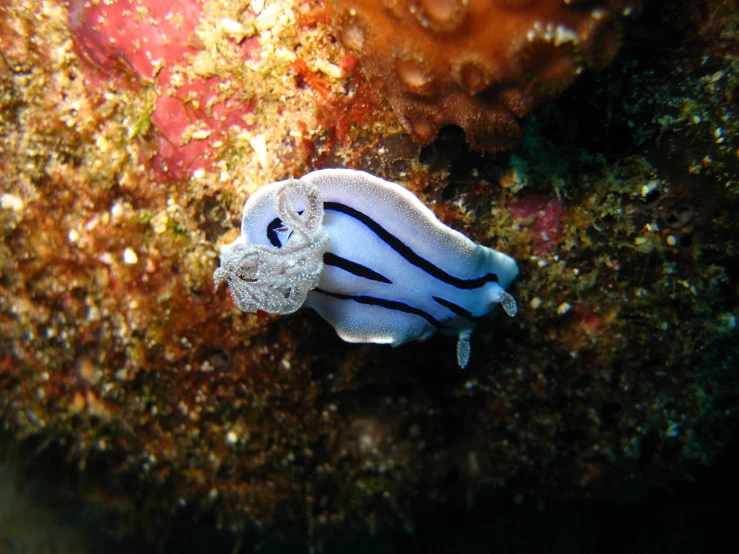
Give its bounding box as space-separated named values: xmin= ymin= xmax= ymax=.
xmin=334 ymin=0 xmax=641 ymax=151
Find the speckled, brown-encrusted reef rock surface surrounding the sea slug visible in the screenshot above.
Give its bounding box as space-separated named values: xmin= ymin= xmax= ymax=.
xmin=0 ymin=0 xmax=739 ymax=549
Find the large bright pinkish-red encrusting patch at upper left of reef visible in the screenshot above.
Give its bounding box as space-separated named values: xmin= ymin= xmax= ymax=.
xmin=69 ymin=0 xmax=258 ymax=180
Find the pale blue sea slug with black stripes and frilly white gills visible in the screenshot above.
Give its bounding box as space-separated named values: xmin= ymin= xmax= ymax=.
xmin=213 ymin=169 xmax=518 ymax=368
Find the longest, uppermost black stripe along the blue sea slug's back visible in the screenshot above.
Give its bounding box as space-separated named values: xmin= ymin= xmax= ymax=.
xmin=323 ymin=202 xmax=498 ymax=290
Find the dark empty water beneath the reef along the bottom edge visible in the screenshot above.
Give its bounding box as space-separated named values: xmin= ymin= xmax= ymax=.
xmin=0 ymin=426 xmax=739 ymax=554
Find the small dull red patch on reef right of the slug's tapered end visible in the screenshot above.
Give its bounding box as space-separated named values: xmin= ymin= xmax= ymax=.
xmin=508 ymin=194 xmax=564 ymax=256
